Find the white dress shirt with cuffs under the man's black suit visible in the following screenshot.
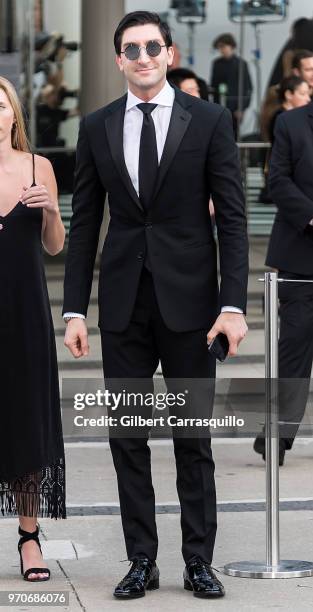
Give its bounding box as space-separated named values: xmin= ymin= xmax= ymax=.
xmin=63 ymin=81 xmax=242 ymax=319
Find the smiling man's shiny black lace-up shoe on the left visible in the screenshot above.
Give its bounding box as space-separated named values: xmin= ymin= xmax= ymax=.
xmin=113 ymin=557 xmax=160 ymax=599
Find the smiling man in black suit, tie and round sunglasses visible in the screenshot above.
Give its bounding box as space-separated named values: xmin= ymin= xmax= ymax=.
xmin=63 ymin=11 xmax=248 ymax=599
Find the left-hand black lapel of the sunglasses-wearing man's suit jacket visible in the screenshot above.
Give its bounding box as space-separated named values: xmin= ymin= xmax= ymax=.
xmin=105 ymin=96 xmax=143 ymax=211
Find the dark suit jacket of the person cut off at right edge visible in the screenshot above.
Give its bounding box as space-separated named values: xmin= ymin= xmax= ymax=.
xmin=266 ymin=102 xmax=313 ymax=275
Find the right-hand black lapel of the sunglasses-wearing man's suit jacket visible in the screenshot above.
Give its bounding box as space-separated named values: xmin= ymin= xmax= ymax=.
xmin=154 ymin=90 xmax=192 ymax=199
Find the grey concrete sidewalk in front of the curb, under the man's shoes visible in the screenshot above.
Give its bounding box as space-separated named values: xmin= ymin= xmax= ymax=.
xmin=0 ymin=512 xmax=313 ymax=612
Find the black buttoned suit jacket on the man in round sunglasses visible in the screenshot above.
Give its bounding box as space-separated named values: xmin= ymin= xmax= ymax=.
xmin=63 ymin=88 xmax=248 ymax=331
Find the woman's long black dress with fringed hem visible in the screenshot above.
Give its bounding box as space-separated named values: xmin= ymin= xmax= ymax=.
xmin=0 ymin=156 xmax=66 ymax=518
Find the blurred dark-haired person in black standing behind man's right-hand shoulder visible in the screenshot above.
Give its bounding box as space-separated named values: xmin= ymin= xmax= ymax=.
xmin=211 ymin=34 xmax=253 ymax=138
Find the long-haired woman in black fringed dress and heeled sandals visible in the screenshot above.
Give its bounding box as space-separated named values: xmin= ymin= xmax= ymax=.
xmin=0 ymin=77 xmax=66 ymax=581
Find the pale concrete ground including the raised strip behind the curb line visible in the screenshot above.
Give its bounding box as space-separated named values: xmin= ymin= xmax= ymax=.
xmin=0 ymin=439 xmax=313 ymax=612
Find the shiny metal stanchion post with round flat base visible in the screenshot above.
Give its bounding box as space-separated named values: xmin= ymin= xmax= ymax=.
xmin=224 ymin=272 xmax=313 ymax=578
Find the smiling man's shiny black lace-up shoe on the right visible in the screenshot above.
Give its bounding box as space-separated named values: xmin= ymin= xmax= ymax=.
xmin=184 ymin=557 xmax=225 ymax=597
